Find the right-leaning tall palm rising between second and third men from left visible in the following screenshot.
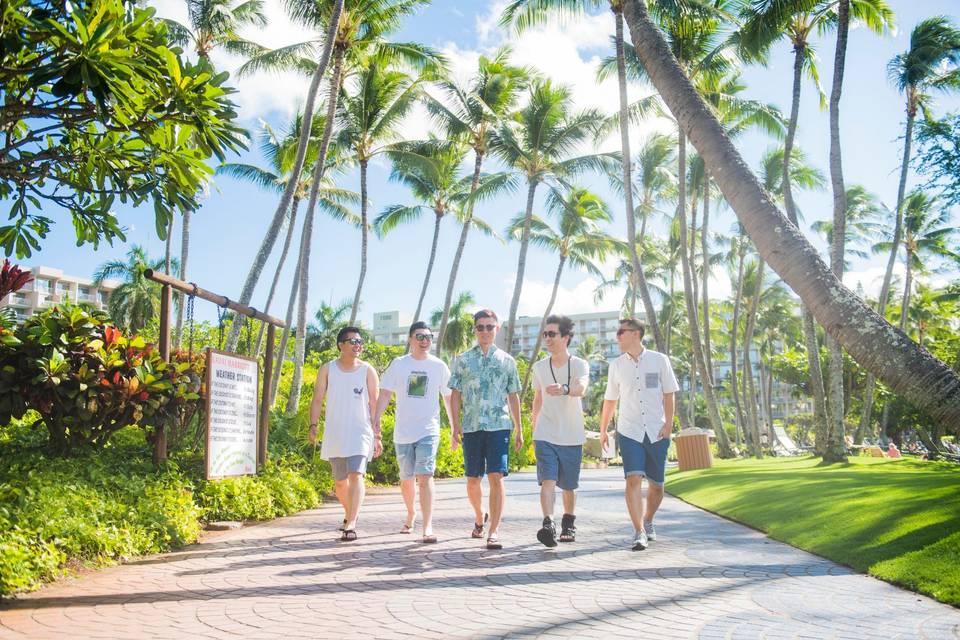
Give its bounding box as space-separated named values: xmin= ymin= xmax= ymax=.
xmin=427 ymin=48 xmax=530 ymax=350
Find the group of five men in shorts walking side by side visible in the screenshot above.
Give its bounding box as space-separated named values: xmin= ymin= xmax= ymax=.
xmin=310 ymin=309 xmax=678 ymax=551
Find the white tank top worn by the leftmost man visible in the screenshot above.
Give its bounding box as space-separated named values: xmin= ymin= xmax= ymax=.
xmin=320 ymin=360 xmax=373 ymax=460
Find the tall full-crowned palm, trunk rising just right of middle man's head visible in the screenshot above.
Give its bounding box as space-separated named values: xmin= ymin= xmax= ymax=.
xmin=491 ymin=80 xmax=612 ymax=351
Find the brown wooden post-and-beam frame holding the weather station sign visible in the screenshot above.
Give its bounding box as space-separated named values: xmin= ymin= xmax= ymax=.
xmin=144 ymin=269 xmax=286 ymax=470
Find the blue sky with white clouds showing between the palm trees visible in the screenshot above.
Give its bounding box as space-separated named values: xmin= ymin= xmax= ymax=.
xmin=24 ymin=0 xmax=960 ymax=325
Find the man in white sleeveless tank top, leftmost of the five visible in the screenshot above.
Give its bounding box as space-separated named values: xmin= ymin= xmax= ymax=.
xmin=310 ymin=327 xmax=383 ymax=542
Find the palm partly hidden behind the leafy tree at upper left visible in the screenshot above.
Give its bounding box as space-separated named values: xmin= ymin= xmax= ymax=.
xmin=164 ymin=0 xmax=267 ymax=346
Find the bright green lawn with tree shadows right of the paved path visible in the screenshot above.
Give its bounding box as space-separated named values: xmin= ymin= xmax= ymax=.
xmin=667 ymin=457 xmax=960 ymax=606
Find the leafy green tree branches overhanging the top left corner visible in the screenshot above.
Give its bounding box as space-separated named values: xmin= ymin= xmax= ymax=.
xmin=0 ymin=0 xmax=245 ymax=257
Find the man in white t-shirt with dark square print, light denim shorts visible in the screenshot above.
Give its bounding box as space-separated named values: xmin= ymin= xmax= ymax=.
xmin=374 ymin=322 xmax=450 ymax=543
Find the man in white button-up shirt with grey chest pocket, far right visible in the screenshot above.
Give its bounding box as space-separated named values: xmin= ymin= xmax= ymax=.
xmin=600 ymin=318 xmax=680 ymax=551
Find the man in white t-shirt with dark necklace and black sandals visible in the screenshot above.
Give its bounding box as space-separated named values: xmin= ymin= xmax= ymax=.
xmin=533 ymin=315 xmax=590 ymax=547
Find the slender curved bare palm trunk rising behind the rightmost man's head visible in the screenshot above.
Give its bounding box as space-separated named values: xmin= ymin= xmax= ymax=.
xmin=613 ymin=5 xmax=666 ymax=353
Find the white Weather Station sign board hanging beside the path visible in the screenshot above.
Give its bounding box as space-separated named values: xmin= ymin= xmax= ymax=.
xmin=207 ymin=349 xmax=259 ymax=480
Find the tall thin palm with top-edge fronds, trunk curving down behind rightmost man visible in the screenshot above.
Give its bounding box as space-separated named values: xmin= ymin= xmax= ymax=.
xmin=500 ymin=0 xmax=666 ymax=353
